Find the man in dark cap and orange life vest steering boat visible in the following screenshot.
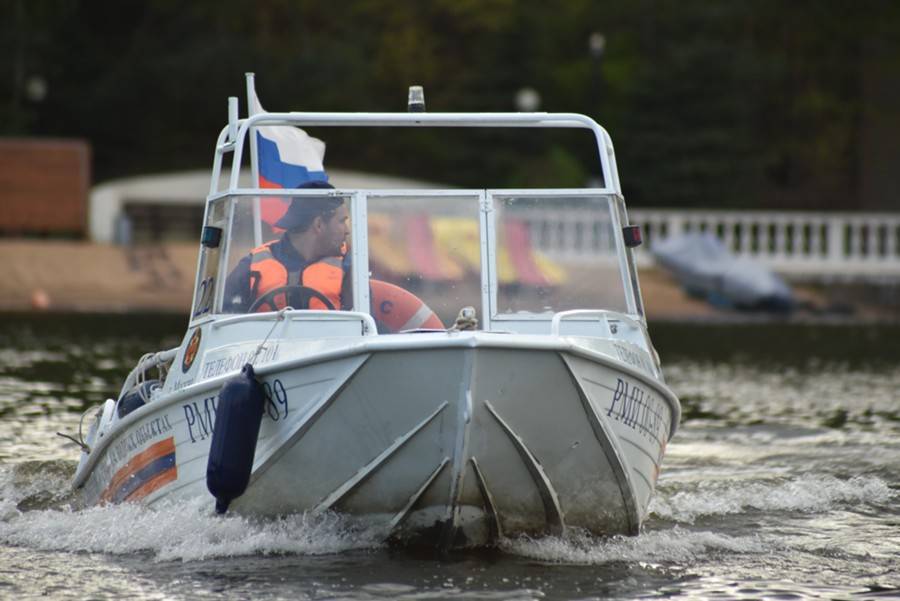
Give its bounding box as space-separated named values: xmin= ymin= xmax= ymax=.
xmin=225 ymin=180 xmax=352 ymax=313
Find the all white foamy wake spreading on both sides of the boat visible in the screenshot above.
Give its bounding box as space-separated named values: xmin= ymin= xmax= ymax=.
xmin=0 ymin=461 xmax=898 ymax=565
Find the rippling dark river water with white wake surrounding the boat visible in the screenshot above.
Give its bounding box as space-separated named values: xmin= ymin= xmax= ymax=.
xmin=0 ymin=315 xmax=900 ymax=600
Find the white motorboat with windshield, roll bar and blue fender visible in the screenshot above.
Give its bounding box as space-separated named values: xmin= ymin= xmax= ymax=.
xmin=73 ymin=80 xmax=681 ymax=549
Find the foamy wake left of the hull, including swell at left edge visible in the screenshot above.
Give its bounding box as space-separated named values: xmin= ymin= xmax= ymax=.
xmin=0 ymin=462 xmax=380 ymax=561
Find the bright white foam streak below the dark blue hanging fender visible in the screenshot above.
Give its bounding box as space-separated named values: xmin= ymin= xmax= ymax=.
xmin=0 ymin=494 xmax=375 ymax=561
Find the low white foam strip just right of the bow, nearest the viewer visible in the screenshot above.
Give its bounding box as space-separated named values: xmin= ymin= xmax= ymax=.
xmin=502 ymin=526 xmax=768 ymax=565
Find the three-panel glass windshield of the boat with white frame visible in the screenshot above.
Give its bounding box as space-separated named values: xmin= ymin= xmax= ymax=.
xmin=194 ymin=190 xmax=640 ymax=330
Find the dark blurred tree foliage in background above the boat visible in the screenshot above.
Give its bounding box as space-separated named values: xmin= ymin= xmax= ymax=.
xmin=0 ymin=0 xmax=900 ymax=208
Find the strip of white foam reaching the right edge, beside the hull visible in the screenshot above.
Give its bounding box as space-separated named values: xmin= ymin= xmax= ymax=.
xmin=650 ymin=475 xmax=897 ymax=523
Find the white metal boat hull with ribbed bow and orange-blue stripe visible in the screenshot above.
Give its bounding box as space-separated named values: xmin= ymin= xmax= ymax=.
xmin=76 ymin=334 xmax=678 ymax=548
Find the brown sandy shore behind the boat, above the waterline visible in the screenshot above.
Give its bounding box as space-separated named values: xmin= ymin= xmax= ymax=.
xmin=0 ymin=239 xmax=898 ymax=321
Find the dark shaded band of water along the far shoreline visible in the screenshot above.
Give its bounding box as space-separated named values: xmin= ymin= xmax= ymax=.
xmin=0 ymin=313 xmax=900 ymax=366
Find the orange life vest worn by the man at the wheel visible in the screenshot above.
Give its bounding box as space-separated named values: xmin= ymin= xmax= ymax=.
xmin=250 ymin=241 xmax=344 ymax=312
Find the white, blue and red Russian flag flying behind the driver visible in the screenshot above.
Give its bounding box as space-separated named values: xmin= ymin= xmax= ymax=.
xmin=250 ymin=92 xmax=328 ymax=224
